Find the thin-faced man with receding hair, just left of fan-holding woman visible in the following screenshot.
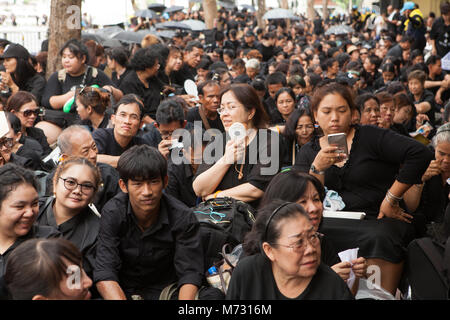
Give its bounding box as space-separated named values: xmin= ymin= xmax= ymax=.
xmin=186 ymin=80 xmax=225 ymax=132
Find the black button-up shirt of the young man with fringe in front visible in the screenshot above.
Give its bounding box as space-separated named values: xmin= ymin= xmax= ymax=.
xmin=93 ymin=193 xmax=205 ymax=299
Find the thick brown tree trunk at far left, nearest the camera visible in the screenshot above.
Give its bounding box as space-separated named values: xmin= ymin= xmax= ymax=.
xmin=47 ymin=0 xmax=81 ymax=78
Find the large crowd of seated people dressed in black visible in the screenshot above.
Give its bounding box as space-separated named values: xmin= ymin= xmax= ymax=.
xmin=0 ymin=2 xmax=450 ymax=300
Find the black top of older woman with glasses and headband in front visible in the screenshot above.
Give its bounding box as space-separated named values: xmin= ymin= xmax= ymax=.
xmin=226 ymin=254 xmax=354 ymax=300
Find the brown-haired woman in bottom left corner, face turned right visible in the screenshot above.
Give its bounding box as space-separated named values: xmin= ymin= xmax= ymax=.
xmin=5 ymin=238 xmax=92 ymax=300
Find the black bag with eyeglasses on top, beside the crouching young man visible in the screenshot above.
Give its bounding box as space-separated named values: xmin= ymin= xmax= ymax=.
xmin=194 ymin=197 xmax=255 ymax=268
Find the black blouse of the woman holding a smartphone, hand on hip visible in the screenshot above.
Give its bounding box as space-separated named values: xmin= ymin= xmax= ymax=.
xmin=295 ymin=125 xmax=433 ymax=218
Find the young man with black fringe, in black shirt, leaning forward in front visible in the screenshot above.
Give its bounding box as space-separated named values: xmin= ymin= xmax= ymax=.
xmin=94 ymin=145 xmax=216 ymax=300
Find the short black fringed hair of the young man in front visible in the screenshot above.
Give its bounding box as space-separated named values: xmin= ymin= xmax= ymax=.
xmin=117 ymin=144 xmax=167 ymax=184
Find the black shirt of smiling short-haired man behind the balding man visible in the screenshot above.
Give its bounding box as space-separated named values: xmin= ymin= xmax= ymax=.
xmin=92 ymin=128 xmax=144 ymax=156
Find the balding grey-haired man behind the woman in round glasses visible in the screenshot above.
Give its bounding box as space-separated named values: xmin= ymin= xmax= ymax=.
xmin=45 ymin=125 xmax=120 ymax=211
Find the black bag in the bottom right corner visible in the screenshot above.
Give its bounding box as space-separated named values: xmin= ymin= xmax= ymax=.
xmin=405 ymin=237 xmax=450 ymax=300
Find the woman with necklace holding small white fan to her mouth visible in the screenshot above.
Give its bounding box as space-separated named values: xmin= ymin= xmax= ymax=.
xmin=193 ymin=84 xmax=282 ymax=207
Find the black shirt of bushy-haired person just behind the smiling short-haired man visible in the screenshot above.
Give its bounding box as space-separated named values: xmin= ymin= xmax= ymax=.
xmin=119 ymin=71 xmax=162 ymax=119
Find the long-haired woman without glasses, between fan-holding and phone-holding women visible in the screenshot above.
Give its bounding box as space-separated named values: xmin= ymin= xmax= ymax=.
xmin=270 ymin=87 xmax=296 ymax=128
